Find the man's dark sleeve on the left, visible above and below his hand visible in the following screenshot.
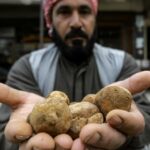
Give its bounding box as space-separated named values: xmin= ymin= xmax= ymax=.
xmin=0 ymin=55 xmax=41 ymax=150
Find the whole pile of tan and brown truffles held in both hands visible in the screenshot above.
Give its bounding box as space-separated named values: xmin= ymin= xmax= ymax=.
xmin=28 ymin=86 xmax=132 ymax=139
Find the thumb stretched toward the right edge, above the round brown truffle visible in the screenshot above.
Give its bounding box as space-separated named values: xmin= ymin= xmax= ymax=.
xmin=111 ymin=71 xmax=150 ymax=94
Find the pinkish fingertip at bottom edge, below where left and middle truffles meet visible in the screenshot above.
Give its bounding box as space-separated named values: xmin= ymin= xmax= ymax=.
xmin=55 ymin=134 xmax=73 ymax=150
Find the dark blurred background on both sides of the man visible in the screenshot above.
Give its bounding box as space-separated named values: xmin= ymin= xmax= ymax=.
xmin=0 ymin=0 xmax=150 ymax=82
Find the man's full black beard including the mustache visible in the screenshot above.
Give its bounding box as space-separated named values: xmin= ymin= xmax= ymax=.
xmin=52 ymin=28 xmax=96 ymax=65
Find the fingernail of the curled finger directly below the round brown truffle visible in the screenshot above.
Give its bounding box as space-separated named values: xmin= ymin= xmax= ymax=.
xmin=107 ymin=116 xmax=122 ymax=128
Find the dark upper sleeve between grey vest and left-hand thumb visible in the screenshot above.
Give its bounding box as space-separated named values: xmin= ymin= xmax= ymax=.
xmin=6 ymin=54 xmax=42 ymax=95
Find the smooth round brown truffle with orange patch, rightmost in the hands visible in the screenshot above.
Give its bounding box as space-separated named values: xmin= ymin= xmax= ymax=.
xmin=95 ymin=86 xmax=133 ymax=116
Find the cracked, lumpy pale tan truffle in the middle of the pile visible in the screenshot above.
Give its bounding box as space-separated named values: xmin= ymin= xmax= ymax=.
xmin=68 ymin=102 xmax=103 ymax=138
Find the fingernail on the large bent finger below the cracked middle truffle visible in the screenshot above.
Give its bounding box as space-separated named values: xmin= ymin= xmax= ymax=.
xmin=85 ymin=133 xmax=101 ymax=144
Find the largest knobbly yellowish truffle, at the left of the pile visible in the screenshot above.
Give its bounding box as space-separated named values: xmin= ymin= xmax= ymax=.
xmin=28 ymin=92 xmax=72 ymax=136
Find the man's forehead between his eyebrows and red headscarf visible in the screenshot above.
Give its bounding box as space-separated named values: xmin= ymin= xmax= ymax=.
xmin=54 ymin=0 xmax=92 ymax=9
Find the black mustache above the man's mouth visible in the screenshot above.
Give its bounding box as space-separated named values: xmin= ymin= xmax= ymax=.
xmin=65 ymin=29 xmax=88 ymax=40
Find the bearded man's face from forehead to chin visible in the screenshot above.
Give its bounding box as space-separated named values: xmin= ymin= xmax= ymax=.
xmin=52 ymin=0 xmax=95 ymax=48
